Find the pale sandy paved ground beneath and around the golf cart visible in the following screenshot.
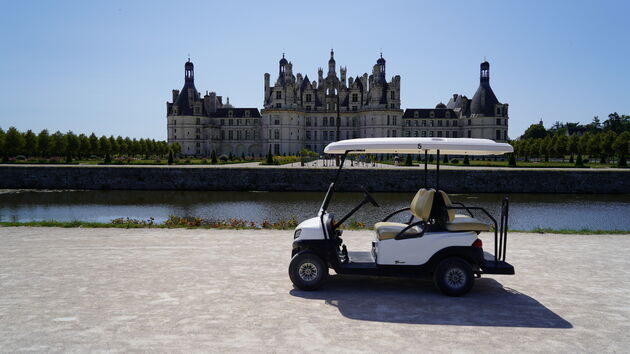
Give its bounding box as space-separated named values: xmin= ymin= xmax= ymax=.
xmin=0 ymin=228 xmax=630 ymax=353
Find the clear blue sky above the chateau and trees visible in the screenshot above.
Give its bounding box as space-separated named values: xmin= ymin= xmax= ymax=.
xmin=0 ymin=0 xmax=630 ymax=139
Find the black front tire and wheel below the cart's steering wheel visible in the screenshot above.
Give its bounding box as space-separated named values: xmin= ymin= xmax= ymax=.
xmin=289 ymin=253 xmax=328 ymax=290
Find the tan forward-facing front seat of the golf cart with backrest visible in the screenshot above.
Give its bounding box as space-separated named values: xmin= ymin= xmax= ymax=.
xmin=374 ymin=188 xmax=435 ymax=241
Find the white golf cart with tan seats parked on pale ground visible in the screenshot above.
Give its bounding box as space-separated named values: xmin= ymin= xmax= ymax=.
xmin=289 ymin=138 xmax=514 ymax=296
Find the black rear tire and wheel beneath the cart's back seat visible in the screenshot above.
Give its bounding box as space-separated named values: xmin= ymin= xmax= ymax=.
xmin=433 ymin=257 xmax=475 ymax=296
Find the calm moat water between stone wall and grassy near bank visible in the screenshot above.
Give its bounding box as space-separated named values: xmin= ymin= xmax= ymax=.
xmin=0 ymin=190 xmax=630 ymax=230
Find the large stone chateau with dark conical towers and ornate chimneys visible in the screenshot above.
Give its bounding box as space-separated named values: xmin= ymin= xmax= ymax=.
xmin=166 ymin=50 xmax=508 ymax=156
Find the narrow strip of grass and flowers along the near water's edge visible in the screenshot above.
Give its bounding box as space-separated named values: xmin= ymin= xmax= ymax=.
xmin=0 ymin=217 xmax=630 ymax=235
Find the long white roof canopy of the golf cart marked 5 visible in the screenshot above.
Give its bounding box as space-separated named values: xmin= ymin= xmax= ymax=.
xmin=324 ymin=138 xmax=514 ymax=155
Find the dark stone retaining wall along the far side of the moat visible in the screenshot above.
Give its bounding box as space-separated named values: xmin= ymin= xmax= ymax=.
xmin=0 ymin=165 xmax=630 ymax=193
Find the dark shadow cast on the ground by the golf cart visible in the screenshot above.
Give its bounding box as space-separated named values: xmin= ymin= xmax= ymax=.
xmin=290 ymin=275 xmax=573 ymax=328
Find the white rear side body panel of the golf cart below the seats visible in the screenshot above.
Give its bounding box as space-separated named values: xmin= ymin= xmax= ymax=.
xmin=374 ymin=232 xmax=477 ymax=265
